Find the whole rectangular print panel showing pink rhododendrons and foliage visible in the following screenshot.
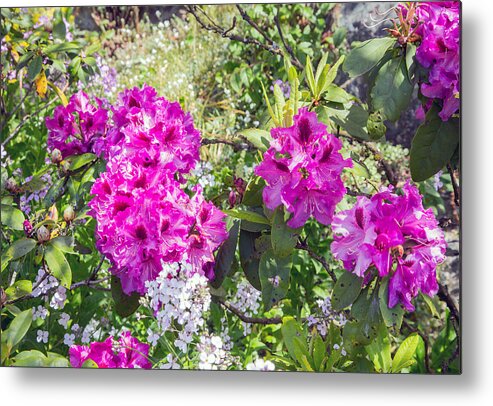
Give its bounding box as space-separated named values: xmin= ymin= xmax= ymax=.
xmin=0 ymin=1 xmax=461 ymax=374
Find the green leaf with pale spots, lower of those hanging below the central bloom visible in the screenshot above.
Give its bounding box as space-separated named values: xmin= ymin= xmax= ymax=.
xmin=259 ymin=249 xmax=292 ymax=310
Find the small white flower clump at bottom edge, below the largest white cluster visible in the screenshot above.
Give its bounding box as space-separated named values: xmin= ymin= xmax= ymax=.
xmin=197 ymin=333 xmax=238 ymax=370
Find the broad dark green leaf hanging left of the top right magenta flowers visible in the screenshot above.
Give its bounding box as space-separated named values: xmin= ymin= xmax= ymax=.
xmin=371 ymin=57 xmax=413 ymax=121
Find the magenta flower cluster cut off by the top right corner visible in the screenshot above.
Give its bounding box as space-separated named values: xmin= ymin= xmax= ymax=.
xmin=416 ymin=1 xmax=460 ymax=121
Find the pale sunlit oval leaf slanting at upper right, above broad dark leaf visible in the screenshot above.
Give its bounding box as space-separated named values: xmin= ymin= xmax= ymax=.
xmin=343 ymin=37 xmax=396 ymax=77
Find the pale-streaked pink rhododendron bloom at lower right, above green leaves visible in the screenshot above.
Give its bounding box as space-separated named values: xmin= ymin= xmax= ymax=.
xmin=331 ymin=183 xmax=447 ymax=311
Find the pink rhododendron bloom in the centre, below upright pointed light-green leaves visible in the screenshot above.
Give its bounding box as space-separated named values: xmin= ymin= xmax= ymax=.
xmin=255 ymin=108 xmax=352 ymax=228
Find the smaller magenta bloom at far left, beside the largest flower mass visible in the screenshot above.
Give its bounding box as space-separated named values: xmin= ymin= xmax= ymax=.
xmin=45 ymin=91 xmax=108 ymax=158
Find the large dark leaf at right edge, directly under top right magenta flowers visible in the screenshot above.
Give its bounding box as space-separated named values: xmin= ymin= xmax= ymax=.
xmin=410 ymin=106 xmax=460 ymax=182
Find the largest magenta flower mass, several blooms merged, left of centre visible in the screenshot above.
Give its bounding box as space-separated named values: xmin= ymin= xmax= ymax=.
xmin=89 ymin=86 xmax=227 ymax=294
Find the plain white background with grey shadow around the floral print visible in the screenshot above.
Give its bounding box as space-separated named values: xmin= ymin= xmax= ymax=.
xmin=0 ymin=0 xmax=493 ymax=406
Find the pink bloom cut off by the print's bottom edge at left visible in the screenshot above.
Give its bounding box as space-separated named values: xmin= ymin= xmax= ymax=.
xmin=69 ymin=331 xmax=152 ymax=369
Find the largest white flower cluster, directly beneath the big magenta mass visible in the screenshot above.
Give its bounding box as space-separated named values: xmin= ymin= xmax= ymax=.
xmin=143 ymin=263 xmax=211 ymax=352
